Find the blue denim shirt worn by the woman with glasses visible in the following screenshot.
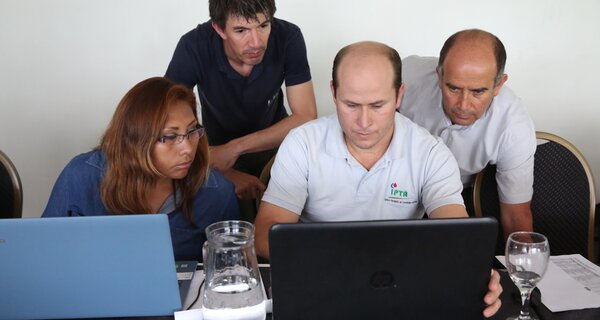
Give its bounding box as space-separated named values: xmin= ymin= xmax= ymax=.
xmin=42 ymin=150 xmax=240 ymax=261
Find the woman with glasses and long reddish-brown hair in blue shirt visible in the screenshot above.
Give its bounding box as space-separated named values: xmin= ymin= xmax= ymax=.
xmin=42 ymin=77 xmax=239 ymax=261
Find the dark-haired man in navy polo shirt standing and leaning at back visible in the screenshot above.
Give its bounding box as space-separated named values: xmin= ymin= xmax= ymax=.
xmin=165 ymin=0 xmax=317 ymax=219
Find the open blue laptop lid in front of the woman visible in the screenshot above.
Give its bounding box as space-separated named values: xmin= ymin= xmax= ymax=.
xmin=0 ymin=214 xmax=181 ymax=320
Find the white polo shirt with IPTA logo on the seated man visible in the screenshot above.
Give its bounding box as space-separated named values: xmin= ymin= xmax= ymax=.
xmin=262 ymin=113 xmax=463 ymax=221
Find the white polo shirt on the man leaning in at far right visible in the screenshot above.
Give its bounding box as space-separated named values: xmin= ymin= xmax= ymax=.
xmin=400 ymin=56 xmax=537 ymax=203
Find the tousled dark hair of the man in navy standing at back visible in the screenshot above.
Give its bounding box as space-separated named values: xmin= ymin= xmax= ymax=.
xmin=208 ymin=0 xmax=277 ymax=29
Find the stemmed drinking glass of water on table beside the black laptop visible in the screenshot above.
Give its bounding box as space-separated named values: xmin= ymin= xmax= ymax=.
xmin=506 ymin=231 xmax=550 ymax=320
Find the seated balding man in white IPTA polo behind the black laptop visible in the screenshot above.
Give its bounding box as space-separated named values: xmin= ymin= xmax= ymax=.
xmin=255 ymin=42 xmax=502 ymax=317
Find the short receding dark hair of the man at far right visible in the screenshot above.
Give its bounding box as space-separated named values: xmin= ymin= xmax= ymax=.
xmin=438 ymin=29 xmax=506 ymax=85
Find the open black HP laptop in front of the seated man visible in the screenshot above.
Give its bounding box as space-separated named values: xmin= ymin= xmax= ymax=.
xmin=269 ymin=218 xmax=498 ymax=320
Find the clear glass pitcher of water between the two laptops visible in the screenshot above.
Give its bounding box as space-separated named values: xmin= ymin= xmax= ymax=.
xmin=202 ymin=221 xmax=266 ymax=320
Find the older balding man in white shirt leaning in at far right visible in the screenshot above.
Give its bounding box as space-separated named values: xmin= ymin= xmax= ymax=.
xmin=400 ymin=29 xmax=536 ymax=236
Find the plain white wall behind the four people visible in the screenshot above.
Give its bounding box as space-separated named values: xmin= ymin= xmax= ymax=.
xmin=0 ymin=0 xmax=600 ymax=217
